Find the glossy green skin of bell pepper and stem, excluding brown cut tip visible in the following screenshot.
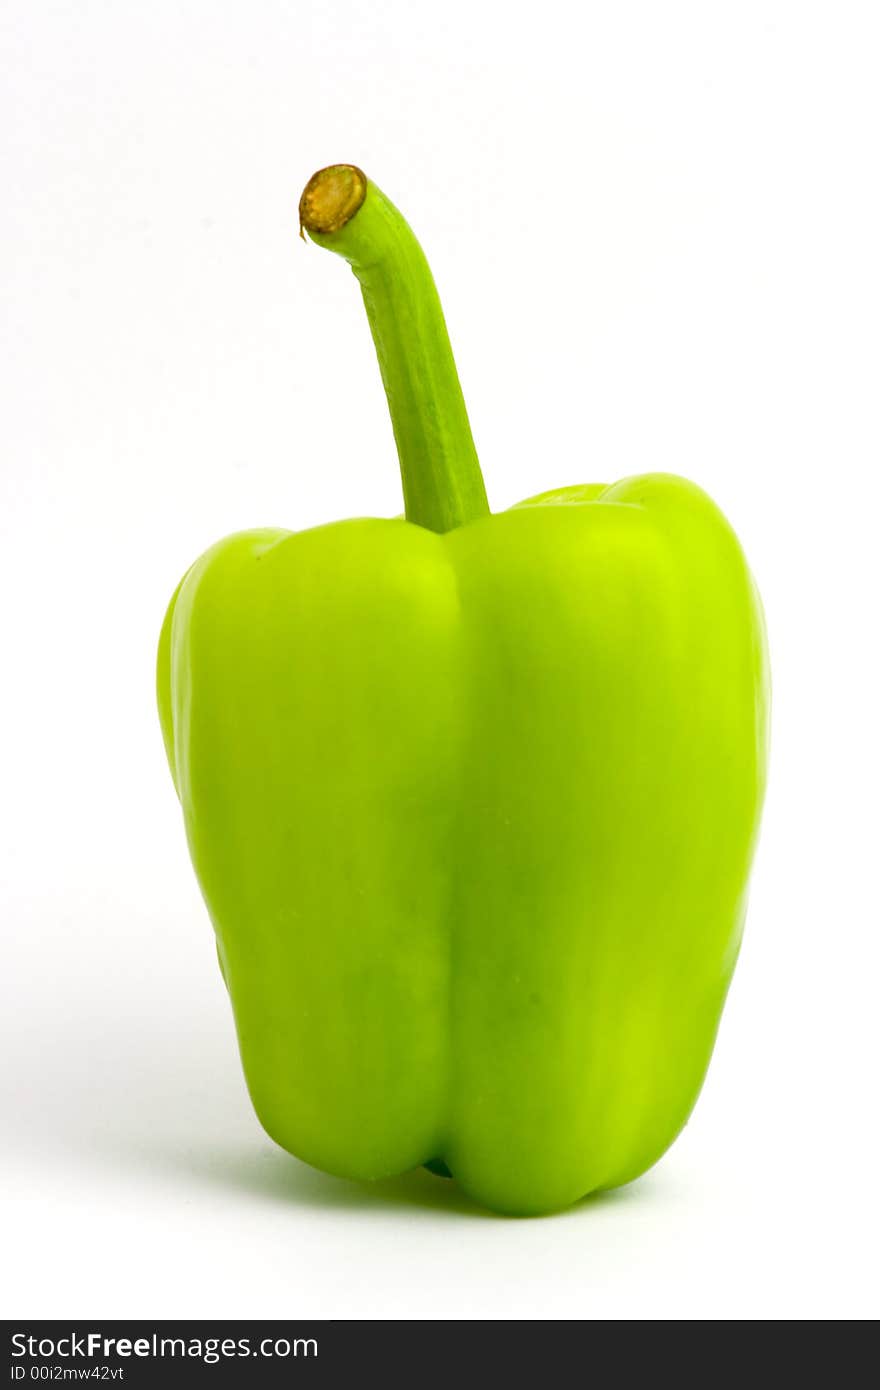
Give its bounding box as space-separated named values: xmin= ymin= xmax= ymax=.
xmin=158 ymin=173 xmax=769 ymax=1213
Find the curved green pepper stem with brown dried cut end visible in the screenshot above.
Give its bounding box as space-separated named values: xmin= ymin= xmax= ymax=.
xmin=299 ymin=164 xmax=489 ymax=531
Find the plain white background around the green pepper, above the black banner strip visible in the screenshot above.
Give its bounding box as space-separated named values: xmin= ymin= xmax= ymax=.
xmin=0 ymin=0 xmax=880 ymax=1319
